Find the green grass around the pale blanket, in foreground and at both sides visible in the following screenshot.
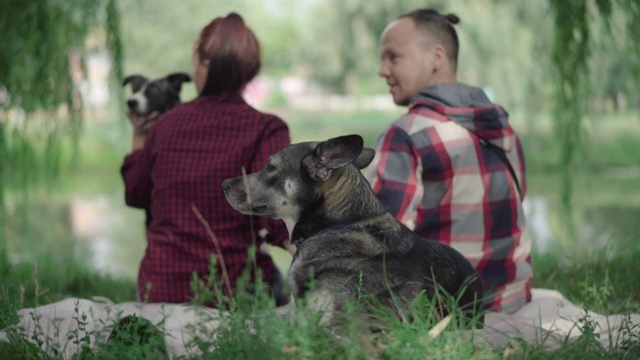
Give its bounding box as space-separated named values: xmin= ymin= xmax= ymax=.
xmin=0 ymin=246 xmax=640 ymax=359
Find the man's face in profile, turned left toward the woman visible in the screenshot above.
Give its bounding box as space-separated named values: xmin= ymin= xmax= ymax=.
xmin=378 ymin=18 xmax=434 ymax=106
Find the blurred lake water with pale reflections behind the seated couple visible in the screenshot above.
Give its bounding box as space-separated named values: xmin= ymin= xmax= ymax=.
xmin=5 ymin=172 xmax=640 ymax=279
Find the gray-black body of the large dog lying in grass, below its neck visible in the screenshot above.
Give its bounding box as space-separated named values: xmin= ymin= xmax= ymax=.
xmin=289 ymin=194 xmax=483 ymax=324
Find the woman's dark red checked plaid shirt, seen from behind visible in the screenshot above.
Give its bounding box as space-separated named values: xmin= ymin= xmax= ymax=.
xmin=121 ymin=96 xmax=290 ymax=305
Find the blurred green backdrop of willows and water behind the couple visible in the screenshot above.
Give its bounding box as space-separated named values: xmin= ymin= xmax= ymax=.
xmin=0 ymin=0 xmax=640 ymax=296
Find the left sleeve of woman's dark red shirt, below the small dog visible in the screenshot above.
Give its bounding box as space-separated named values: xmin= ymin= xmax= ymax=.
xmin=120 ymin=130 xmax=153 ymax=209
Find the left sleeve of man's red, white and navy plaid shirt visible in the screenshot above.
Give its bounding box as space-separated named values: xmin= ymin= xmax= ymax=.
xmin=368 ymin=126 xmax=423 ymax=230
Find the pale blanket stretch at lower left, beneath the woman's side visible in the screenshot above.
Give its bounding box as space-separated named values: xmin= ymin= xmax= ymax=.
xmin=0 ymin=297 xmax=220 ymax=359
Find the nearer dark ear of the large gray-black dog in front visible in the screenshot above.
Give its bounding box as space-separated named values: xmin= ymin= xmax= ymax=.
xmin=302 ymin=135 xmax=363 ymax=181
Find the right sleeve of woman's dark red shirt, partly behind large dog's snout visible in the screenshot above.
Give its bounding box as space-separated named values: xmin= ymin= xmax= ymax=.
xmin=248 ymin=117 xmax=291 ymax=246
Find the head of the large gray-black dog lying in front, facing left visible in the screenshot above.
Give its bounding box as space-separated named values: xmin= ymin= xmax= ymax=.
xmin=222 ymin=135 xmax=375 ymax=231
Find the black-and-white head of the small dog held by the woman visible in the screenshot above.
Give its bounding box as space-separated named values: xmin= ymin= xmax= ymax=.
xmin=122 ymin=73 xmax=191 ymax=128
